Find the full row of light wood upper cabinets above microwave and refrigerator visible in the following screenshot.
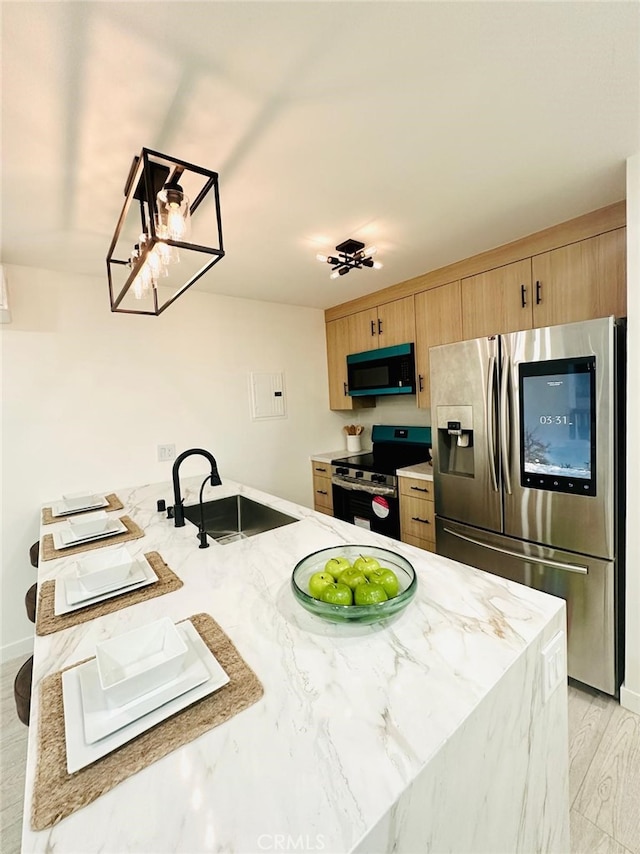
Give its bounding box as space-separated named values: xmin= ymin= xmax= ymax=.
xmin=325 ymin=202 xmax=627 ymax=409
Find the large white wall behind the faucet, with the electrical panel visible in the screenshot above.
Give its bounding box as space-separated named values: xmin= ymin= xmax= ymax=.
xmin=0 ymin=266 xmax=343 ymax=660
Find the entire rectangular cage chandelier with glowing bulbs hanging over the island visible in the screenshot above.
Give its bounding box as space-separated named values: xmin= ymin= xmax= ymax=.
xmin=107 ymin=148 xmax=225 ymax=316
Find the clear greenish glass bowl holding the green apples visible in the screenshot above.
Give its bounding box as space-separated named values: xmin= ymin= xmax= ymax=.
xmin=291 ymin=545 xmax=418 ymax=623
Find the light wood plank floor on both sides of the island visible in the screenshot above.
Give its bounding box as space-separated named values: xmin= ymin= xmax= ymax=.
xmin=0 ymin=656 xmax=640 ymax=854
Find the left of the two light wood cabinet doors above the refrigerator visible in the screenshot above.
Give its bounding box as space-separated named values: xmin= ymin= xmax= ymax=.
xmin=461 ymin=258 xmax=533 ymax=341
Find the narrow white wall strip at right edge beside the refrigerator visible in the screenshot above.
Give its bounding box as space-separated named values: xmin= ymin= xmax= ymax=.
xmin=620 ymin=153 xmax=640 ymax=714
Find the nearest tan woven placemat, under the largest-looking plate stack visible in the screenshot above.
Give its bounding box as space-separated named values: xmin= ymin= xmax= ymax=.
xmin=31 ymin=614 xmax=264 ymax=830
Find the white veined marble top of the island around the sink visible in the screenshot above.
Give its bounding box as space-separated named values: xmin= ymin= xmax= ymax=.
xmin=23 ymin=478 xmax=564 ymax=854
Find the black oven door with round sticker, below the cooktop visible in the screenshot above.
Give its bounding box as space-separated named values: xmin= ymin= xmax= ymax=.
xmin=332 ymin=478 xmax=400 ymax=540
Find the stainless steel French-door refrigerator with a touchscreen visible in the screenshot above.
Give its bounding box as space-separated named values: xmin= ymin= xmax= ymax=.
xmin=429 ymin=318 xmax=624 ymax=695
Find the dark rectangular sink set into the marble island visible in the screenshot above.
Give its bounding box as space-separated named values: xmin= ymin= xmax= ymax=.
xmin=184 ymin=495 xmax=299 ymax=545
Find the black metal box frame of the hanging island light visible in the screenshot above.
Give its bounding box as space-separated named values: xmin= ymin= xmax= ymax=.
xmin=107 ymin=148 xmax=225 ymax=316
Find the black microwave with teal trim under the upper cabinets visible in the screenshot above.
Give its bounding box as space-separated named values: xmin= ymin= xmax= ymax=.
xmin=347 ymin=344 xmax=416 ymax=397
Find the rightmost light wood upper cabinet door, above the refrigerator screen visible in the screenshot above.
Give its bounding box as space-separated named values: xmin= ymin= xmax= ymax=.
xmin=532 ymin=228 xmax=627 ymax=327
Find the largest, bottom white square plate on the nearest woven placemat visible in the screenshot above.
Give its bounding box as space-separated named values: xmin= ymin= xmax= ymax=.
xmin=62 ymin=620 xmax=229 ymax=774
